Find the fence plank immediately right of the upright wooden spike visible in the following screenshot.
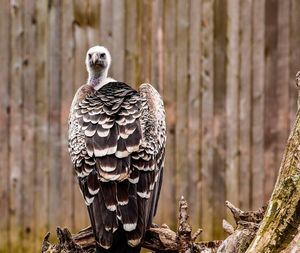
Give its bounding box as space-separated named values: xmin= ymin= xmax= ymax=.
xmin=186 ymin=0 xmax=202 ymax=227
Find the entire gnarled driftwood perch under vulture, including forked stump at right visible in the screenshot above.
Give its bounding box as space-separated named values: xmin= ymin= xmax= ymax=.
xmin=42 ymin=198 xmax=265 ymax=253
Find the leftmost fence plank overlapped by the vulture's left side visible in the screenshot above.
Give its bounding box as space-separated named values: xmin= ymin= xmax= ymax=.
xmin=60 ymin=1 xmax=76 ymax=229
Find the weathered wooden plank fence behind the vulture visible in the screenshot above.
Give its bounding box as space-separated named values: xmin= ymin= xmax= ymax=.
xmin=0 ymin=0 xmax=300 ymax=252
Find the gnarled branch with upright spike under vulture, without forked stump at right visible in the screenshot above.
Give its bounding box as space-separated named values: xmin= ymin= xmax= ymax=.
xmin=42 ymin=197 xmax=222 ymax=253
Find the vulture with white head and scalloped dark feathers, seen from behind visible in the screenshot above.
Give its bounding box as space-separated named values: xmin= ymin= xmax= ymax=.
xmin=68 ymin=45 xmax=166 ymax=253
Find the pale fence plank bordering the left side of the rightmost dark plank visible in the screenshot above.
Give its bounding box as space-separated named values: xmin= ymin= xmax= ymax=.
xmin=251 ymin=0 xmax=265 ymax=209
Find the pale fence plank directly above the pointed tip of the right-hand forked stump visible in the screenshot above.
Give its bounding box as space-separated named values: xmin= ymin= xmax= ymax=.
xmin=225 ymin=0 xmax=240 ymax=215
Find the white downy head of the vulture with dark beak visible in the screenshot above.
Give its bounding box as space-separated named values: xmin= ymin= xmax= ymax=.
xmin=85 ymin=46 xmax=111 ymax=77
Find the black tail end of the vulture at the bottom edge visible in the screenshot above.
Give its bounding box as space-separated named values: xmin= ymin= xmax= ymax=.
xmin=96 ymin=227 xmax=141 ymax=253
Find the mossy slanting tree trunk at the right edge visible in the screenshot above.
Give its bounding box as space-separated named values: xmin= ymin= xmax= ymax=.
xmin=247 ymin=72 xmax=300 ymax=253
